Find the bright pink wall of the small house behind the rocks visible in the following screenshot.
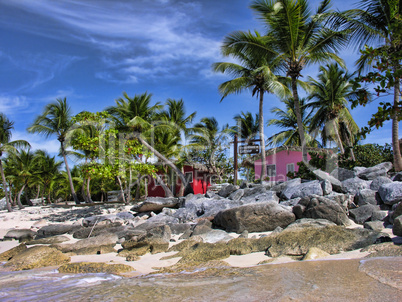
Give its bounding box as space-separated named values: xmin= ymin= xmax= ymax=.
xmin=254 ymin=150 xmax=311 ymax=181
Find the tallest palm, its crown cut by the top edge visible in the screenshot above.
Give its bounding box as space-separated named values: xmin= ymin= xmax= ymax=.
xmin=248 ymin=0 xmax=347 ymax=162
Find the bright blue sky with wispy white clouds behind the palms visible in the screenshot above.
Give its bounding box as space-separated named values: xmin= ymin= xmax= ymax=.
xmin=0 ymin=0 xmax=391 ymax=160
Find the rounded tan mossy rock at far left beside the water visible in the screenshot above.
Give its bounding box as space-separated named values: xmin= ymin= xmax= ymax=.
xmin=4 ymin=246 xmax=70 ymax=271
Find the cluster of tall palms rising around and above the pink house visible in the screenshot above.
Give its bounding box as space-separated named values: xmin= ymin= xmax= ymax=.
xmin=213 ymin=0 xmax=402 ymax=175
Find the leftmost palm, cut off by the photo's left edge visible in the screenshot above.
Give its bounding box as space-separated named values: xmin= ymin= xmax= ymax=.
xmin=0 ymin=113 xmax=29 ymax=212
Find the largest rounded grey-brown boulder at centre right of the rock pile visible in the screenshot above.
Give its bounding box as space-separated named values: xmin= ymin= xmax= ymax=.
xmin=213 ymin=202 xmax=295 ymax=234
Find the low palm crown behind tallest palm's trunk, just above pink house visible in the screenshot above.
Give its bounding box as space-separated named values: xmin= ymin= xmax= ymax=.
xmin=267 ymin=98 xmax=319 ymax=147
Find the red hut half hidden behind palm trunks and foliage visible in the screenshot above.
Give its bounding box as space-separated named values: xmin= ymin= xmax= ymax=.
xmin=148 ymin=165 xmax=212 ymax=197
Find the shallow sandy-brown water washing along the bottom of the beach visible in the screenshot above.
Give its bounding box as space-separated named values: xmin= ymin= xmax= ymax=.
xmin=0 ymin=257 xmax=402 ymax=302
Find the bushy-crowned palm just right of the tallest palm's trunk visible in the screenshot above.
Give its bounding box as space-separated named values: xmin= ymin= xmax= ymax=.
xmin=308 ymin=64 xmax=358 ymax=158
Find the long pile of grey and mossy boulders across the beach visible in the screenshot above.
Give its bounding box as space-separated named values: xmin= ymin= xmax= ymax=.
xmin=0 ymin=163 xmax=402 ymax=270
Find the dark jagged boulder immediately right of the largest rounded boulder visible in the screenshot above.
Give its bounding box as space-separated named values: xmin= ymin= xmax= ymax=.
xmin=293 ymin=196 xmax=350 ymax=225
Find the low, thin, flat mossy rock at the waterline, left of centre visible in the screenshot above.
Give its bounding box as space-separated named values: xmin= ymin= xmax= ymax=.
xmin=59 ymin=262 xmax=135 ymax=275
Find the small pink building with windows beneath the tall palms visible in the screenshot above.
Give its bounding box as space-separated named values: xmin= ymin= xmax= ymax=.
xmin=252 ymin=146 xmax=322 ymax=181
